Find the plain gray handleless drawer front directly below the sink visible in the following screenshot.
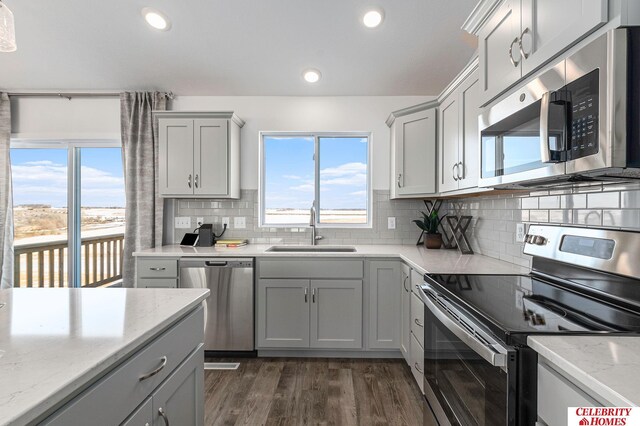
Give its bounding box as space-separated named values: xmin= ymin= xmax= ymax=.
xmin=258 ymin=259 xmax=364 ymax=279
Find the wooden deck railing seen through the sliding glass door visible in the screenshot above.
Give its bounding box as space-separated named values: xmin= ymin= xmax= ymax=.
xmin=14 ymin=234 xmax=124 ymax=287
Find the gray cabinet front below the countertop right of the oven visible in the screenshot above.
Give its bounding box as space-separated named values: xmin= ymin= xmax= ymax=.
xmin=538 ymin=364 xmax=602 ymax=425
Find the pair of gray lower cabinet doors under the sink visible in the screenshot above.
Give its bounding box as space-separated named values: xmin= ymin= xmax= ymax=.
xmin=257 ymin=279 xmax=362 ymax=349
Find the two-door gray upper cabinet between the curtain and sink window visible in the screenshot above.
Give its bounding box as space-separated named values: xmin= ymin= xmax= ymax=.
xmin=155 ymin=111 xmax=244 ymax=198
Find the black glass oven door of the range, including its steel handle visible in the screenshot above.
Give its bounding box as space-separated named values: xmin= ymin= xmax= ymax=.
xmin=420 ymin=284 xmax=516 ymax=426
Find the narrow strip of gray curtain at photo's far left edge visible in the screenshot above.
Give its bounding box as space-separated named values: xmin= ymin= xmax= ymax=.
xmin=0 ymin=93 xmax=13 ymax=288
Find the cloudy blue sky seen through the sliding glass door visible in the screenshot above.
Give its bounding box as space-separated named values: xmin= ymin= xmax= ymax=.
xmin=11 ymin=148 xmax=125 ymax=207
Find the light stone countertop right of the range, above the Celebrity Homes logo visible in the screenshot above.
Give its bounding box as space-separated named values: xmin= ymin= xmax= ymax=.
xmin=527 ymin=336 xmax=640 ymax=407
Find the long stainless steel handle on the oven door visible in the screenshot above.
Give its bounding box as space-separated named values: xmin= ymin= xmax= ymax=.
xmin=420 ymin=286 xmax=507 ymax=367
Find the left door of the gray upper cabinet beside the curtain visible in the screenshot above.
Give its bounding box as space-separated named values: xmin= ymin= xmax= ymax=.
xmin=158 ymin=118 xmax=194 ymax=196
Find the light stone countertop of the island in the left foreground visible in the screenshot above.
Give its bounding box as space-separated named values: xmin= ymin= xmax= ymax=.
xmin=0 ymin=288 xmax=209 ymax=425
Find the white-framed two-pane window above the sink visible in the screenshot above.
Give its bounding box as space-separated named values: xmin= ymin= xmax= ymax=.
xmin=260 ymin=133 xmax=371 ymax=227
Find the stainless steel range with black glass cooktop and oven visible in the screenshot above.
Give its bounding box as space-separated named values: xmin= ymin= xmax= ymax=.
xmin=420 ymin=225 xmax=640 ymax=426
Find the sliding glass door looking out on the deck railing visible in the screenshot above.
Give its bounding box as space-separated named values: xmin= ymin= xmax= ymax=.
xmin=11 ymin=141 xmax=125 ymax=287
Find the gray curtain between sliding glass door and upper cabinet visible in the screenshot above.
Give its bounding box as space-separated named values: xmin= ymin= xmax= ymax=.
xmin=120 ymin=92 xmax=168 ymax=287
